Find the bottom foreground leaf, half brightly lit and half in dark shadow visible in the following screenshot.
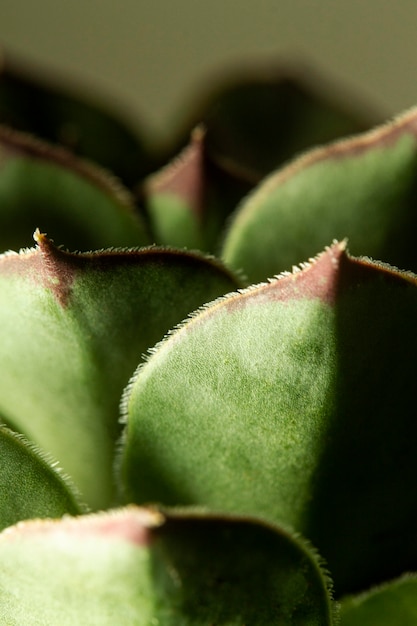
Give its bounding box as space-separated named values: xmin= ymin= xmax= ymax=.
xmin=0 ymin=507 xmax=334 ymax=626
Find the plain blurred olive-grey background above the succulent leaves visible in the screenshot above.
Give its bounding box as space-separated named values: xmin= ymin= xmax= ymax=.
xmin=0 ymin=0 xmax=417 ymax=143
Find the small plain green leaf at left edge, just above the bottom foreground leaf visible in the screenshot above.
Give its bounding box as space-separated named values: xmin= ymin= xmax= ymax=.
xmin=0 ymin=424 xmax=85 ymax=529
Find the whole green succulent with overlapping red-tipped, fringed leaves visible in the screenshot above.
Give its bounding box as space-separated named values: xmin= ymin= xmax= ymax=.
xmin=0 ymin=50 xmax=417 ymax=626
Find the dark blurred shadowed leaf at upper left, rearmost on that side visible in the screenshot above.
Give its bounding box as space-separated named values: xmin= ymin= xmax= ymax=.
xmin=0 ymin=50 xmax=154 ymax=187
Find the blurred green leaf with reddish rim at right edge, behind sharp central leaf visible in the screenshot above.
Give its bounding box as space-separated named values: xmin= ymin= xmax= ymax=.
xmin=223 ymin=109 xmax=417 ymax=282
